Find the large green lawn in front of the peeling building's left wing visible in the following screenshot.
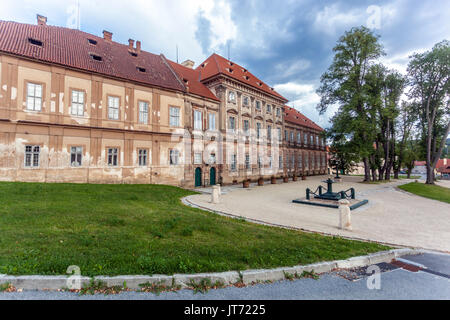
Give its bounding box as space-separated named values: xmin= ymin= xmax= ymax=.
xmin=0 ymin=183 xmax=389 ymax=276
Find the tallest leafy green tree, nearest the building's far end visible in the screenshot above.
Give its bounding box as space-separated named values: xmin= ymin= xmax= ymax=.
xmin=317 ymin=26 xmax=384 ymax=181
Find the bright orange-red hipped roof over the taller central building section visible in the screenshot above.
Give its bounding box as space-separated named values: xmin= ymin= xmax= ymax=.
xmin=196 ymin=53 xmax=288 ymax=102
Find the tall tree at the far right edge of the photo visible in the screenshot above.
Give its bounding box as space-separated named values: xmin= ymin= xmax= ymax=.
xmin=408 ymin=40 xmax=450 ymax=184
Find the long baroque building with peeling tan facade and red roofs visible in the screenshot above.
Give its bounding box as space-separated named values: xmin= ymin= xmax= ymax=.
xmin=0 ymin=16 xmax=326 ymax=187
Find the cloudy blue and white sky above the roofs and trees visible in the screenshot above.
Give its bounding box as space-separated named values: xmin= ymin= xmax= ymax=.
xmin=0 ymin=0 xmax=450 ymax=127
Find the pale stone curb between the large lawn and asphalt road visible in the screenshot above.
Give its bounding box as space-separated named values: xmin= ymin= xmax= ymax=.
xmin=0 ymin=248 xmax=425 ymax=290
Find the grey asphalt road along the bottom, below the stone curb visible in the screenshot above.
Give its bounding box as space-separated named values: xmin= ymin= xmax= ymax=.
xmin=0 ymin=252 xmax=450 ymax=300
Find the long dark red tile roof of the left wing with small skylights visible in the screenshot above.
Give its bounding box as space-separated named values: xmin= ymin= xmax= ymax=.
xmin=0 ymin=21 xmax=185 ymax=91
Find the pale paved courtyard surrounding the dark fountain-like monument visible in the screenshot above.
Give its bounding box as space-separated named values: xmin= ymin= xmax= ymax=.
xmin=187 ymin=176 xmax=450 ymax=252
